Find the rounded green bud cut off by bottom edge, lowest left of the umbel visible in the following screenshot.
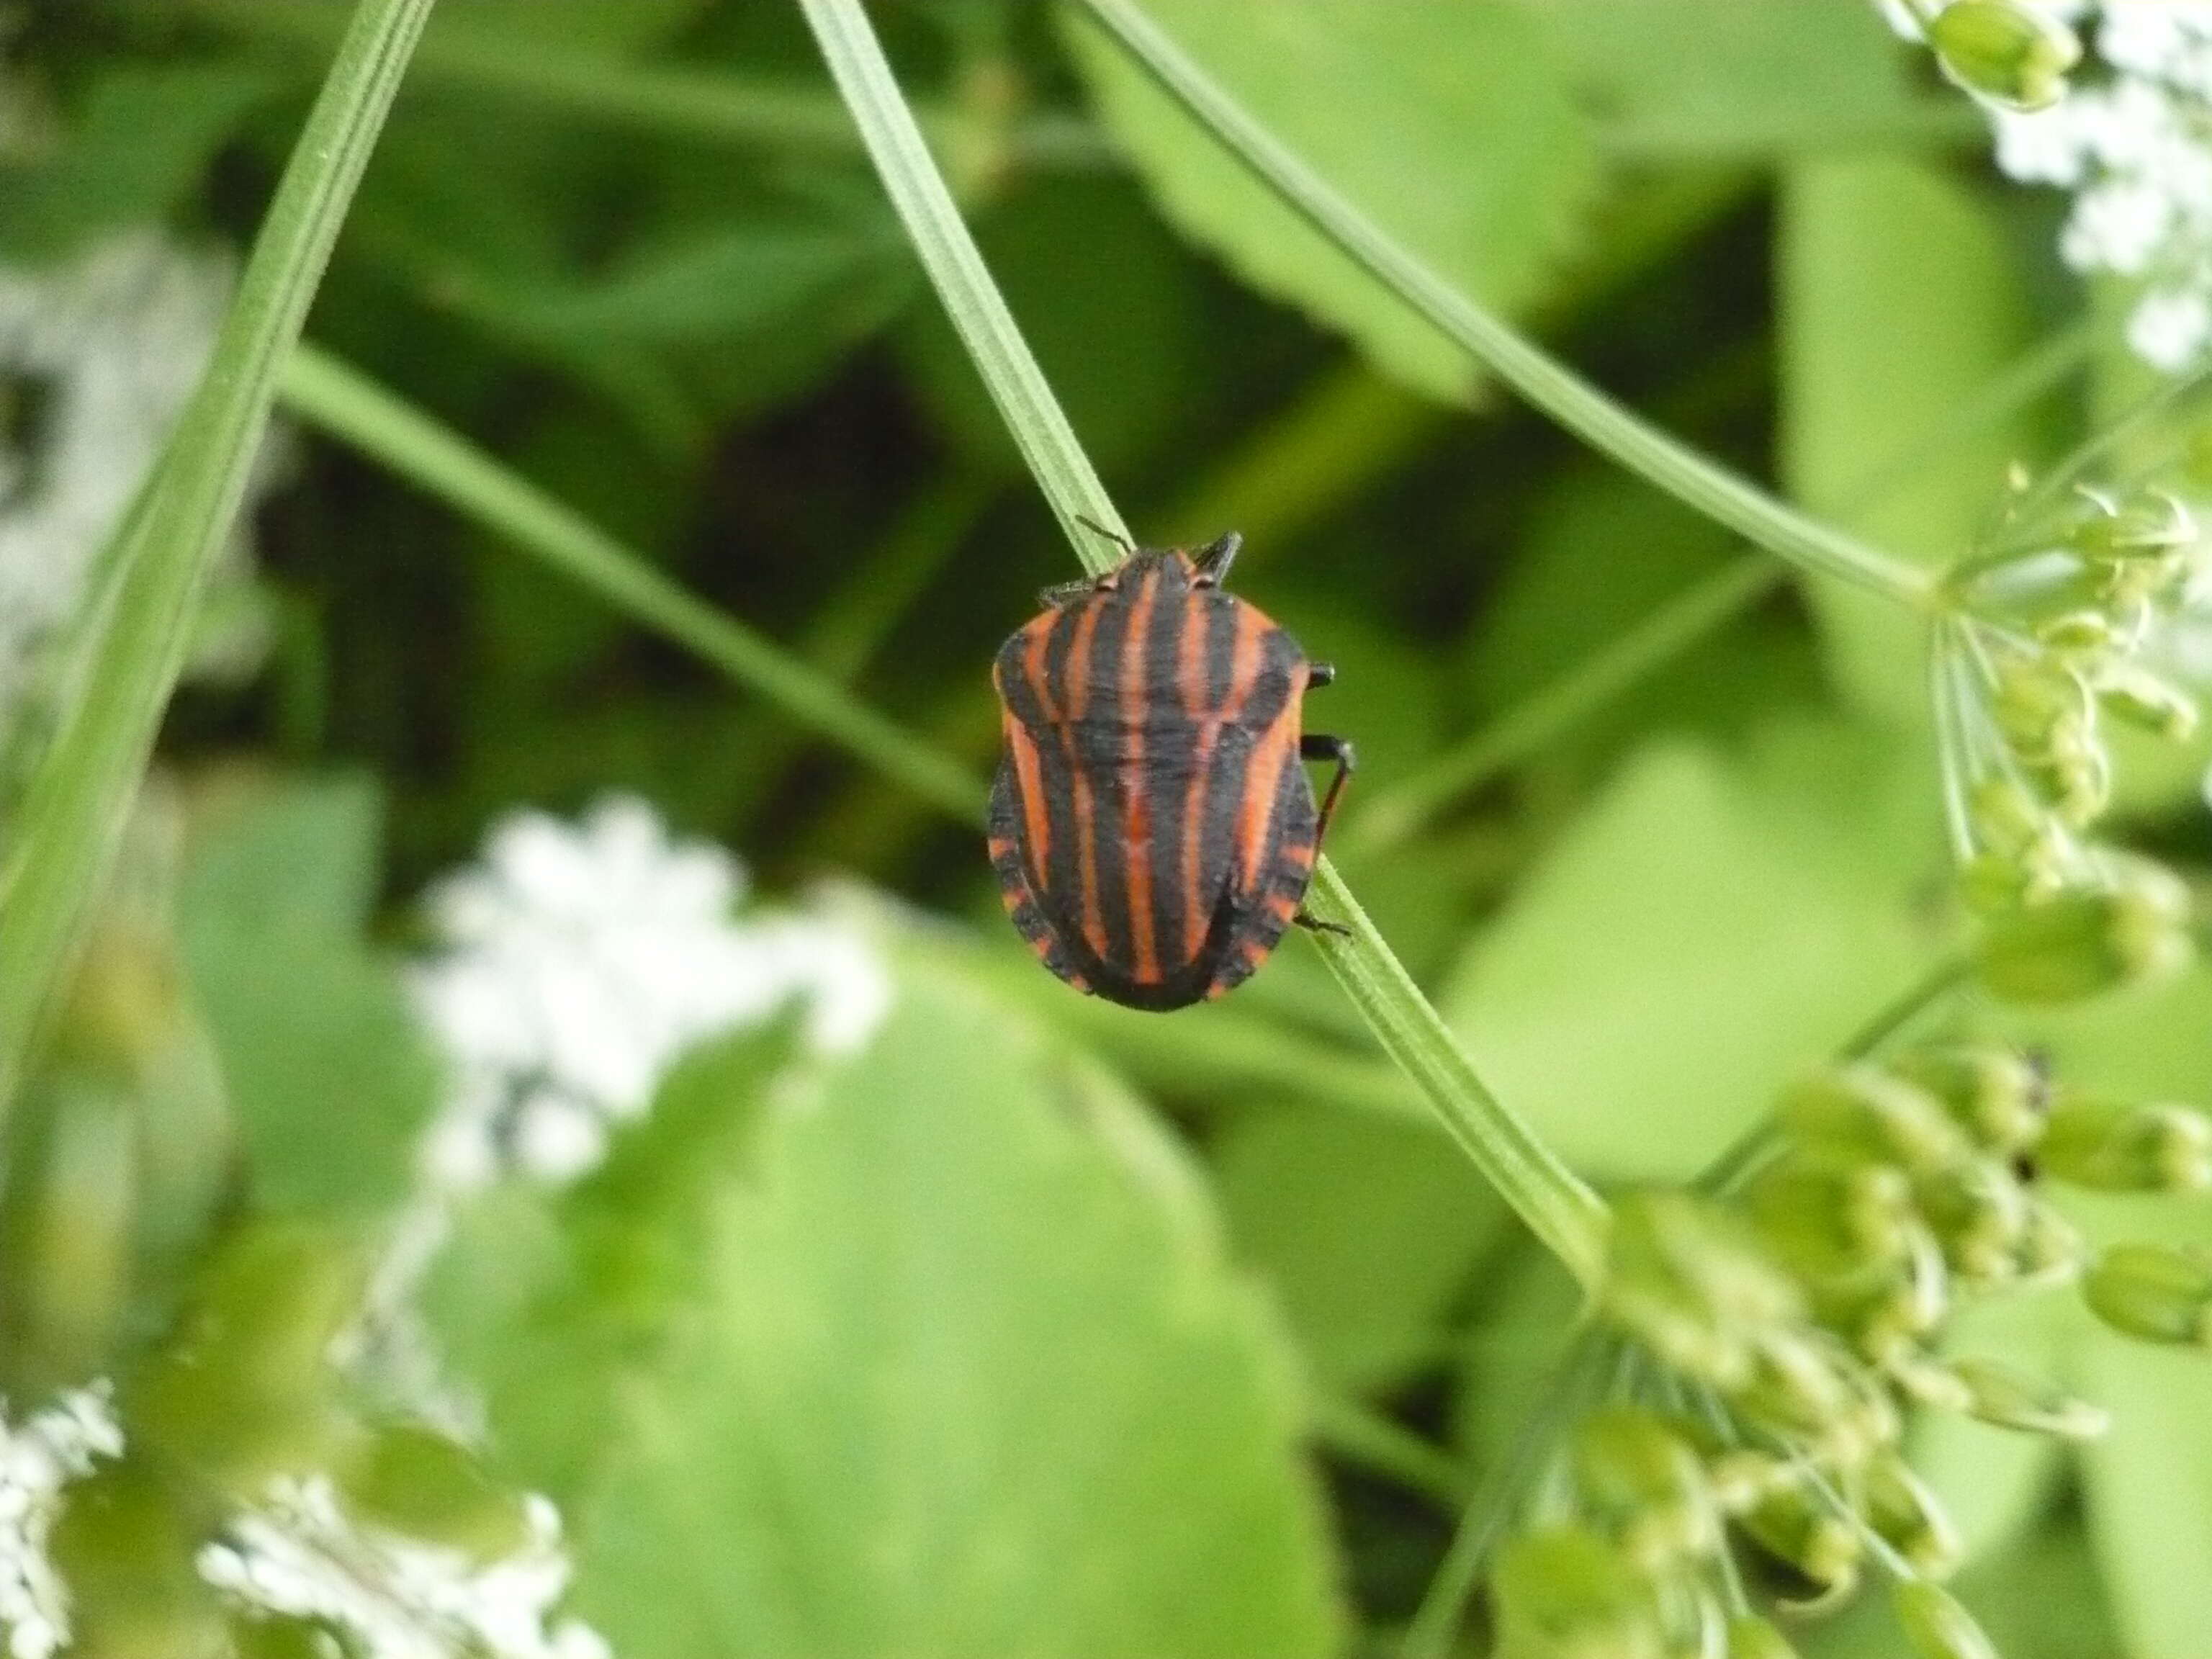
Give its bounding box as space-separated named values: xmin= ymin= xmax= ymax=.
xmin=1491 ymin=1527 xmax=1665 ymax=1659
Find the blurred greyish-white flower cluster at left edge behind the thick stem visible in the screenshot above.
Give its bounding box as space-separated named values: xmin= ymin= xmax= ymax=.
xmin=0 ymin=233 xmax=267 ymax=728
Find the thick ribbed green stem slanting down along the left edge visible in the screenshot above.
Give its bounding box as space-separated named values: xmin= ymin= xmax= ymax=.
xmin=0 ymin=0 xmax=431 ymax=1112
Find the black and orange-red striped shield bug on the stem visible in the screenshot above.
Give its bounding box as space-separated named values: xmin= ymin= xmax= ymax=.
xmin=989 ymin=524 xmax=1354 ymax=1009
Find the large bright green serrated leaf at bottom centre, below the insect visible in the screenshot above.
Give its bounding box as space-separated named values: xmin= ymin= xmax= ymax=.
xmin=544 ymin=984 xmax=1339 ymax=1659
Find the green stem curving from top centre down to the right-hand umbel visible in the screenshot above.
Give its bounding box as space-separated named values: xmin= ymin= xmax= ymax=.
xmin=1075 ymin=0 xmax=1938 ymax=608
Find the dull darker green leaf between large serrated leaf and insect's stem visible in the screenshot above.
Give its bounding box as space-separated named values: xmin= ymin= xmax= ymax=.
xmin=1215 ymin=1106 xmax=1506 ymax=1393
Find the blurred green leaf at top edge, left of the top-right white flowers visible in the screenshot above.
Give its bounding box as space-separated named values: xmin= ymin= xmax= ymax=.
xmin=1519 ymin=0 xmax=1966 ymax=157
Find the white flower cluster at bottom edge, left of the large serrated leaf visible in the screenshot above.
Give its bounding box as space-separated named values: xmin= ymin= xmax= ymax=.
xmin=199 ymin=1475 xmax=608 ymax=1659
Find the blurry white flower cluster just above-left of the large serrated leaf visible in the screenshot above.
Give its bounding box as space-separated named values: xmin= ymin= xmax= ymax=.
xmin=413 ymin=799 xmax=891 ymax=1195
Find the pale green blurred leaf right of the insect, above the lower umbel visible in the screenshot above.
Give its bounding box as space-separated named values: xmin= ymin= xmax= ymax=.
xmin=1440 ymin=724 xmax=1940 ymax=1179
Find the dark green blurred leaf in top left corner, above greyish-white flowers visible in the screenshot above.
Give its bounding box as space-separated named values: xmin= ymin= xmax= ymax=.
xmin=0 ymin=62 xmax=287 ymax=258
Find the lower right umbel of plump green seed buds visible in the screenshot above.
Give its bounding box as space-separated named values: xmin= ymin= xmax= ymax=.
xmin=1491 ymin=1042 xmax=2212 ymax=1659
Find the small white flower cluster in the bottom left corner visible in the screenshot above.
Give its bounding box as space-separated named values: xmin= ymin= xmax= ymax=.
xmin=0 ymin=1387 xmax=124 ymax=1659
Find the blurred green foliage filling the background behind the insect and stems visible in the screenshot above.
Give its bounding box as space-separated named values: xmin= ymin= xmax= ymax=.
xmin=0 ymin=0 xmax=2212 ymax=1659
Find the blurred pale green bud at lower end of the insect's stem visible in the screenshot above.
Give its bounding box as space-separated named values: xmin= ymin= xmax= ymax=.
xmin=1599 ymin=1192 xmax=1801 ymax=1387
